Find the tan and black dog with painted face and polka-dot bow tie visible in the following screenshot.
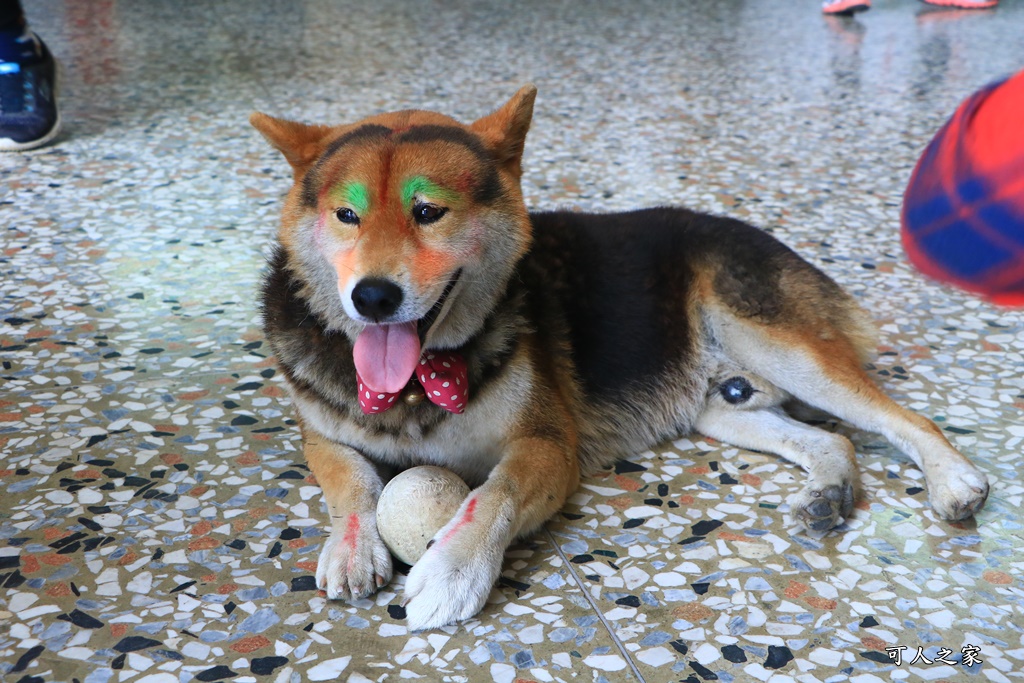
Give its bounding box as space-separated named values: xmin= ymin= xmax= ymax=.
xmin=251 ymin=86 xmax=988 ymax=629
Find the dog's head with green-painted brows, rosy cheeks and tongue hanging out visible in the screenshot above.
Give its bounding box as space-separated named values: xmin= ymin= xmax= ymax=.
xmin=250 ymin=85 xmax=537 ymax=391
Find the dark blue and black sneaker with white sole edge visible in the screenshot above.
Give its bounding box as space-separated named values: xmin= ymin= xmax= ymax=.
xmin=0 ymin=33 xmax=60 ymax=152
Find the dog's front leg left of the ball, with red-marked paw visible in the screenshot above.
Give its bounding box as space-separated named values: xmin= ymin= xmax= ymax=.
xmin=302 ymin=427 xmax=391 ymax=599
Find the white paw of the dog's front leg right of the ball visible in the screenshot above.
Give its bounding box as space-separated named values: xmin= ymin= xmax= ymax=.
xmin=406 ymin=544 xmax=504 ymax=631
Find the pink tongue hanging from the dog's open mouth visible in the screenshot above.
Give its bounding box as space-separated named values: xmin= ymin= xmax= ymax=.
xmin=352 ymin=322 xmax=420 ymax=393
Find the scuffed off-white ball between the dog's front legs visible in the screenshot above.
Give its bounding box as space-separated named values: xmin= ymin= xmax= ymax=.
xmin=377 ymin=466 xmax=469 ymax=564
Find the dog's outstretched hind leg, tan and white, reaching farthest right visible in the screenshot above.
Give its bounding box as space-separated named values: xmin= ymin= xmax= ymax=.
xmin=716 ymin=317 xmax=988 ymax=520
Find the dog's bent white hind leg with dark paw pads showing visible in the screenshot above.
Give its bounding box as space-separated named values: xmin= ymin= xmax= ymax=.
xmin=694 ymin=405 xmax=858 ymax=532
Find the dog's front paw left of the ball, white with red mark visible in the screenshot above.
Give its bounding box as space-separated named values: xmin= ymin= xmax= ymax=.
xmin=316 ymin=512 xmax=391 ymax=600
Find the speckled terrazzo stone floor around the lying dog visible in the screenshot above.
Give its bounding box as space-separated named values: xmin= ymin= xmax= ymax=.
xmin=0 ymin=0 xmax=1024 ymax=683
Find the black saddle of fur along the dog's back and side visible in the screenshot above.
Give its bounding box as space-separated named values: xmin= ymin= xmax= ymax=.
xmin=519 ymin=208 xmax=807 ymax=402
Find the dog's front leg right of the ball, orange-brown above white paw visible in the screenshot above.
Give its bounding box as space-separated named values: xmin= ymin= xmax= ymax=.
xmin=406 ymin=436 xmax=580 ymax=630
